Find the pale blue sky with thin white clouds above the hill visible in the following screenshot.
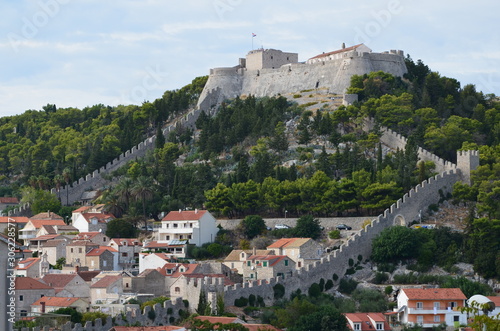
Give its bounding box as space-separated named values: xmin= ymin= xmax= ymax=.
xmin=0 ymin=0 xmax=500 ymax=116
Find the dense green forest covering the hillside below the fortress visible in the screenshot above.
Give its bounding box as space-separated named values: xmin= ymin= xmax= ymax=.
xmin=0 ymin=57 xmax=500 ymax=277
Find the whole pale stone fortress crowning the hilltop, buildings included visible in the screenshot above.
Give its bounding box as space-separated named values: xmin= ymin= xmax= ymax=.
xmin=197 ymin=44 xmax=407 ymax=110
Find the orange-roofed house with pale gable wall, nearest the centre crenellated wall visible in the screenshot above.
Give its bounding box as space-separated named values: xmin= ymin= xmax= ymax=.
xmin=267 ymin=238 xmax=323 ymax=269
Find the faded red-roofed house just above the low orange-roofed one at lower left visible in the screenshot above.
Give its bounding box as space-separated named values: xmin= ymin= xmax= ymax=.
xmin=41 ymin=273 xmax=90 ymax=299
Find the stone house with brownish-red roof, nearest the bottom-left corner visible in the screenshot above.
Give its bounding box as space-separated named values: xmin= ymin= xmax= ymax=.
xmin=15 ymin=277 xmax=55 ymax=316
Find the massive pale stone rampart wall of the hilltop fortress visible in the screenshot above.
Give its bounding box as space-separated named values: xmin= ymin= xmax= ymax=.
xmin=198 ymin=51 xmax=407 ymax=110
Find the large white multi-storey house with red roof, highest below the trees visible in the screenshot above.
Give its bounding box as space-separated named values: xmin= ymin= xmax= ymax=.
xmin=157 ymin=209 xmax=219 ymax=246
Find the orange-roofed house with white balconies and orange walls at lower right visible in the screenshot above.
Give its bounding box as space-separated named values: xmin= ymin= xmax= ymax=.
xmin=395 ymin=288 xmax=467 ymax=328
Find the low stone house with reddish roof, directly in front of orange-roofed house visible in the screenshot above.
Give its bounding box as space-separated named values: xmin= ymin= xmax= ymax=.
xmin=243 ymin=255 xmax=296 ymax=280
